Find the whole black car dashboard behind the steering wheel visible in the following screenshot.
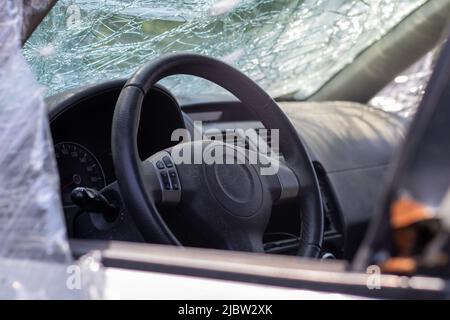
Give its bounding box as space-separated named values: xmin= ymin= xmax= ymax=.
xmin=47 ymin=80 xmax=405 ymax=259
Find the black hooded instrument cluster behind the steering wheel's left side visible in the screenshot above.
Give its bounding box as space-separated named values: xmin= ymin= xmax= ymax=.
xmin=50 ymin=82 xmax=184 ymax=207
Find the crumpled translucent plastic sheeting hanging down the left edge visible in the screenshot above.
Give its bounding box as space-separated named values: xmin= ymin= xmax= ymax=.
xmin=0 ymin=0 xmax=101 ymax=299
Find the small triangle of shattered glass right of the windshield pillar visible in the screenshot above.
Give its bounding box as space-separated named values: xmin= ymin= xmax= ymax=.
xmin=369 ymin=50 xmax=437 ymax=118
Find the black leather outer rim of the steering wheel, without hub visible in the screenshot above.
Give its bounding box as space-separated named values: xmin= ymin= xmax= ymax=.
xmin=111 ymin=54 xmax=324 ymax=257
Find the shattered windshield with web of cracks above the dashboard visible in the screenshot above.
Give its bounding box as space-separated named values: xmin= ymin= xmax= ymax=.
xmin=24 ymin=0 xmax=426 ymax=99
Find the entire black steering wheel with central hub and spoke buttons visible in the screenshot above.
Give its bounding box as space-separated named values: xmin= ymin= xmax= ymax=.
xmin=111 ymin=54 xmax=324 ymax=257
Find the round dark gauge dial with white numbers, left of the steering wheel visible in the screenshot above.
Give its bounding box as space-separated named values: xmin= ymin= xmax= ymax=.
xmin=55 ymin=142 xmax=106 ymax=206
